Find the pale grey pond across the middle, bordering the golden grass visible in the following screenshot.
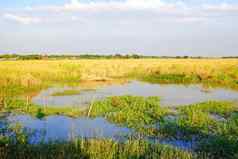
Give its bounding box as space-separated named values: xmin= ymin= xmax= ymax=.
xmin=32 ymin=81 xmax=238 ymax=107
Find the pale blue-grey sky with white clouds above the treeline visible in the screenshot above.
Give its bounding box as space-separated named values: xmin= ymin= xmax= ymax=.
xmin=0 ymin=0 xmax=238 ymax=57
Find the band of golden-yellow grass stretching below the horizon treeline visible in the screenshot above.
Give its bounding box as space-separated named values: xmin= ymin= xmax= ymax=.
xmin=0 ymin=59 xmax=238 ymax=92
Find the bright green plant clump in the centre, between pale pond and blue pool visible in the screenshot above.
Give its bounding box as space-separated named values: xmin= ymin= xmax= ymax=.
xmin=90 ymin=96 xmax=169 ymax=132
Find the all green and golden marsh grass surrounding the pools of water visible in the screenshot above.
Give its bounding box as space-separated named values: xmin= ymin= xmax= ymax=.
xmin=0 ymin=59 xmax=238 ymax=159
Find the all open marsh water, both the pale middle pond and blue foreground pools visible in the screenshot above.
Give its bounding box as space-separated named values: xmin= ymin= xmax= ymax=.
xmin=0 ymin=81 xmax=238 ymax=149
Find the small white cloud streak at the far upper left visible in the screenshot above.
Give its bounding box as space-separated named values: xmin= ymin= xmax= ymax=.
xmin=3 ymin=13 xmax=42 ymax=24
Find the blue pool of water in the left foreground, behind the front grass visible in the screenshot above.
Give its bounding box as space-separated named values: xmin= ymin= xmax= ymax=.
xmin=6 ymin=114 xmax=133 ymax=142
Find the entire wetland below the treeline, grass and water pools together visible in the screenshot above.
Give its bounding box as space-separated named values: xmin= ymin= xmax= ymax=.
xmin=0 ymin=59 xmax=238 ymax=159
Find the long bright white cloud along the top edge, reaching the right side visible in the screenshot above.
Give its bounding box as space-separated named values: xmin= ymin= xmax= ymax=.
xmin=25 ymin=0 xmax=238 ymax=13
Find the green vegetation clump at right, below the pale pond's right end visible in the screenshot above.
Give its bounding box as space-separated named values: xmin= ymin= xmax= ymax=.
xmin=160 ymin=101 xmax=238 ymax=137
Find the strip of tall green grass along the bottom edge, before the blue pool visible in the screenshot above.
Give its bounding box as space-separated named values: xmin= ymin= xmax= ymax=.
xmin=0 ymin=139 xmax=195 ymax=159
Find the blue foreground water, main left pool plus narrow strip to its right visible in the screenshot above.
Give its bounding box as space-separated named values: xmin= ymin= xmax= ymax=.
xmin=3 ymin=114 xmax=195 ymax=150
